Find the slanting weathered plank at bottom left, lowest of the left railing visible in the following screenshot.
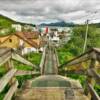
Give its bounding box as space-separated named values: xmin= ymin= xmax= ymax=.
xmin=3 ymin=81 xmax=18 ymax=100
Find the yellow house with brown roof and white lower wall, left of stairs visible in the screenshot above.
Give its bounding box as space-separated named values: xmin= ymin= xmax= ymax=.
xmin=0 ymin=32 xmax=43 ymax=54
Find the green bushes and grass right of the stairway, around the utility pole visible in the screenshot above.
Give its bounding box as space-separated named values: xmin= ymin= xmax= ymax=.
xmin=58 ymin=25 xmax=100 ymax=95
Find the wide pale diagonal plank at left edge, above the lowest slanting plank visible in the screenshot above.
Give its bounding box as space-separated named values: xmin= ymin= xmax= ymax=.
xmin=0 ymin=69 xmax=17 ymax=93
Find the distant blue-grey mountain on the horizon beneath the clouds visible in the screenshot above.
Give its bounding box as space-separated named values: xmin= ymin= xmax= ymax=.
xmin=39 ymin=21 xmax=75 ymax=27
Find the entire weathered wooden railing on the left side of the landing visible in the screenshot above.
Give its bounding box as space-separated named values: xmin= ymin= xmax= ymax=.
xmin=0 ymin=48 xmax=39 ymax=100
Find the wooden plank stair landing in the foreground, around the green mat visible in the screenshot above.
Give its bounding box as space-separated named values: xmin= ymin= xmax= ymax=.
xmin=14 ymin=77 xmax=90 ymax=100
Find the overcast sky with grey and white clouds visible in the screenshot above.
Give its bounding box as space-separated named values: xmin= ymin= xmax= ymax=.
xmin=0 ymin=0 xmax=100 ymax=24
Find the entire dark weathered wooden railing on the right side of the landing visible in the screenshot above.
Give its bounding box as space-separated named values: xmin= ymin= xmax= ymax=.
xmin=59 ymin=48 xmax=100 ymax=100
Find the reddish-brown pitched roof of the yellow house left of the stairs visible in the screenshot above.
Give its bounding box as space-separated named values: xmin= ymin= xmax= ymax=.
xmin=0 ymin=32 xmax=42 ymax=48
